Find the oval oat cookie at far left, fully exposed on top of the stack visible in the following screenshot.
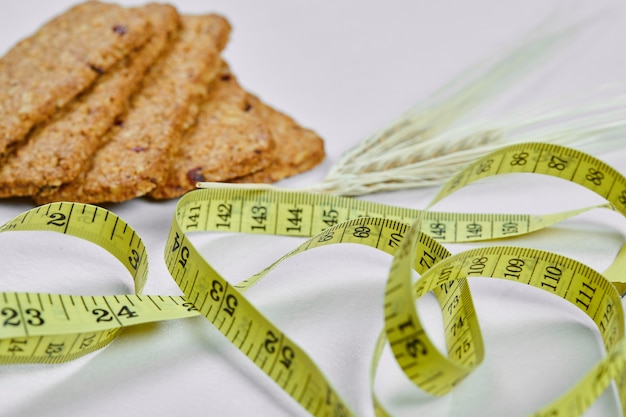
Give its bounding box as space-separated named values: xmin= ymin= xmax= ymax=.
xmin=0 ymin=1 xmax=152 ymax=156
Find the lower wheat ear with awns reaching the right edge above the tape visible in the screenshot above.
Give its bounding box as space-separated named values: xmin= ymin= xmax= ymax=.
xmin=311 ymin=87 xmax=626 ymax=196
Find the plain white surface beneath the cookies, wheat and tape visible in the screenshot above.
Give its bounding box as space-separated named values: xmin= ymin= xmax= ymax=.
xmin=0 ymin=0 xmax=626 ymax=417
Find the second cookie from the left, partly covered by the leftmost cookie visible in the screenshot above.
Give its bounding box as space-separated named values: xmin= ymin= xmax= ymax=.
xmin=0 ymin=4 xmax=180 ymax=197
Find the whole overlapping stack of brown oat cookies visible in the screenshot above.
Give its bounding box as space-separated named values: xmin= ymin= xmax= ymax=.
xmin=0 ymin=1 xmax=324 ymax=204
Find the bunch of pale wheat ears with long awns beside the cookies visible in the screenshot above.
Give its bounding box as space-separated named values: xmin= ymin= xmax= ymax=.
xmin=308 ymin=12 xmax=626 ymax=196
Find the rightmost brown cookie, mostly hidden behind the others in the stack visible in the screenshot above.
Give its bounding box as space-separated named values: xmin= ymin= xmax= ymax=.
xmin=231 ymin=100 xmax=325 ymax=183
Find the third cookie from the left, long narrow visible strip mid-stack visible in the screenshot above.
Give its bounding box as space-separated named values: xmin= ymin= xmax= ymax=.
xmin=36 ymin=15 xmax=230 ymax=203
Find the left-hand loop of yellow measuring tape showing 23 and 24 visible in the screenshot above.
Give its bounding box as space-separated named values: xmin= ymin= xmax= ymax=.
xmin=0 ymin=203 xmax=198 ymax=363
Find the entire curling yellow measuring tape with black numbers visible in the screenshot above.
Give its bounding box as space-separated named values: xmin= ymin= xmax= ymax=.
xmin=0 ymin=143 xmax=626 ymax=417
